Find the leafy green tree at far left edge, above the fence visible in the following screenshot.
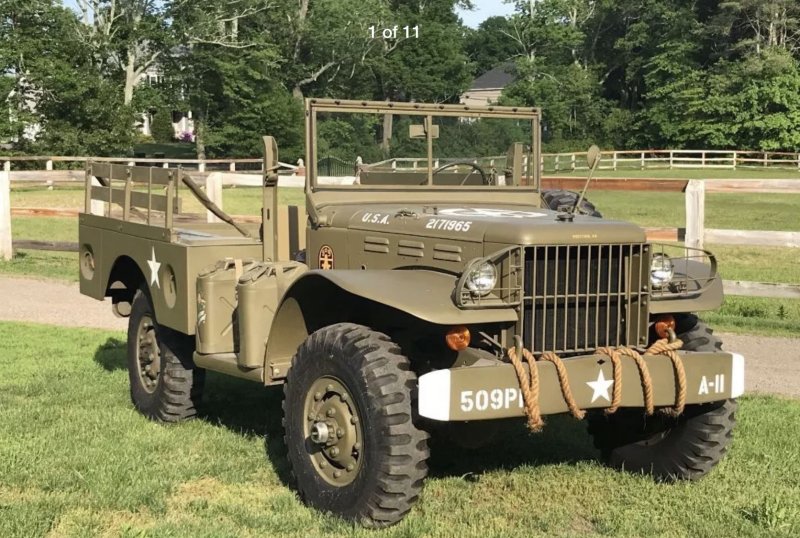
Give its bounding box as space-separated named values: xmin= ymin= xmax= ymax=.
xmin=0 ymin=0 xmax=133 ymax=155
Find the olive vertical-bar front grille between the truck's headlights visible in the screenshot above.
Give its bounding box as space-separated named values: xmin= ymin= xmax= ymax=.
xmin=523 ymin=244 xmax=649 ymax=355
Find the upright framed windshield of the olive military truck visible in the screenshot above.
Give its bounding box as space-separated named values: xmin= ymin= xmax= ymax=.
xmin=308 ymin=101 xmax=539 ymax=189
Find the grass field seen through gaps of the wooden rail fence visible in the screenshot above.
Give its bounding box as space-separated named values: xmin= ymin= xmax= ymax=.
xmin=0 ymin=187 xmax=800 ymax=336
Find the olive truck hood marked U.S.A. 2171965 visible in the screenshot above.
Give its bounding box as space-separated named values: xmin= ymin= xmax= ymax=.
xmin=333 ymin=204 xmax=646 ymax=245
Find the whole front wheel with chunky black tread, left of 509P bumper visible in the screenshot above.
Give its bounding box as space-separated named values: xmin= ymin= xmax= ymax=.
xmin=283 ymin=323 xmax=428 ymax=527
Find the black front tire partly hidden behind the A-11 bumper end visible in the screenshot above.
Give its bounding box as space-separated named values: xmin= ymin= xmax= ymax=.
xmin=588 ymin=315 xmax=737 ymax=481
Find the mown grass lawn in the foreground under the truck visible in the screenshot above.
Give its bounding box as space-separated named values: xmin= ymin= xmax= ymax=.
xmin=0 ymin=323 xmax=800 ymax=537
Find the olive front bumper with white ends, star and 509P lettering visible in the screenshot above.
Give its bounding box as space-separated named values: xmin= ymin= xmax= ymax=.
xmin=418 ymin=351 xmax=744 ymax=421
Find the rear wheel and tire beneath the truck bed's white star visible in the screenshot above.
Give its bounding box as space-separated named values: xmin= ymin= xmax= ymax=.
xmin=128 ymin=288 xmax=205 ymax=422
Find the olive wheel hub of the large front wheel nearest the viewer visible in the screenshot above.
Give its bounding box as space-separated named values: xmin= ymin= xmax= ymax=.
xmin=304 ymin=376 xmax=363 ymax=486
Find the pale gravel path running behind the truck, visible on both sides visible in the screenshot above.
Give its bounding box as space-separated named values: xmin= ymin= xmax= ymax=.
xmin=0 ymin=276 xmax=800 ymax=398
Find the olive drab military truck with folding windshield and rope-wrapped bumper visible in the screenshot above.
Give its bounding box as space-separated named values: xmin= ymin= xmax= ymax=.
xmin=80 ymin=99 xmax=744 ymax=527
